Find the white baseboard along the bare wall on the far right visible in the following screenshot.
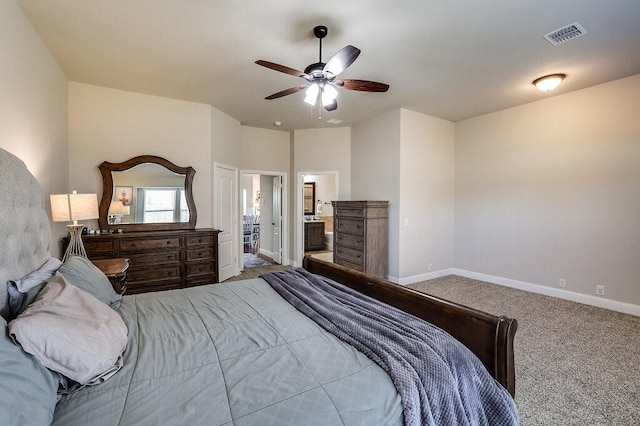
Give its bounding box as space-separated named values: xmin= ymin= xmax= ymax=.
xmin=449 ymin=268 xmax=640 ymax=316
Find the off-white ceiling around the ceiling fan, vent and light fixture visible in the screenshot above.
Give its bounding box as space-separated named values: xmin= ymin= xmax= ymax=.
xmin=17 ymin=0 xmax=640 ymax=130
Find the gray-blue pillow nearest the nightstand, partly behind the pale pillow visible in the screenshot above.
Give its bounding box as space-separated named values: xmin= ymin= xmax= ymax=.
xmin=58 ymin=256 xmax=122 ymax=309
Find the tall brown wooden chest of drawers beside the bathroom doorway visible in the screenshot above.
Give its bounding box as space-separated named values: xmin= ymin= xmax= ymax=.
xmin=331 ymin=201 xmax=389 ymax=279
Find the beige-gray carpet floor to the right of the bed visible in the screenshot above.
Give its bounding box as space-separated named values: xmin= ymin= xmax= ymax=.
xmin=408 ymin=276 xmax=640 ymax=426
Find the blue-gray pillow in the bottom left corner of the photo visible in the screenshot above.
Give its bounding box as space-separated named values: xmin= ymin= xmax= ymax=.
xmin=0 ymin=317 xmax=58 ymax=426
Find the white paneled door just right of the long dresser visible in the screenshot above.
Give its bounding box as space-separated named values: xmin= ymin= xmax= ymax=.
xmin=213 ymin=164 xmax=239 ymax=282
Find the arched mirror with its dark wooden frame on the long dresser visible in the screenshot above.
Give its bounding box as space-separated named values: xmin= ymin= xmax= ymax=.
xmin=98 ymin=155 xmax=197 ymax=231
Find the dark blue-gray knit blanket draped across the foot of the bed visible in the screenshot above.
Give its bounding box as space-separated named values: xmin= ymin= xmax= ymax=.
xmin=262 ymin=268 xmax=518 ymax=426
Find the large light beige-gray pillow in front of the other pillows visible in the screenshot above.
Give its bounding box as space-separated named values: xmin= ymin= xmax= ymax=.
xmin=8 ymin=272 xmax=127 ymax=385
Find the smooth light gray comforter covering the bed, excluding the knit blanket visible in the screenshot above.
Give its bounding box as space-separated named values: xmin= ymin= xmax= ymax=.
xmin=55 ymin=279 xmax=403 ymax=426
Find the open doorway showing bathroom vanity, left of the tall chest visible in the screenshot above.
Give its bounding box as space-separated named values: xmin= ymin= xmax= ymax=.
xmin=296 ymin=171 xmax=338 ymax=262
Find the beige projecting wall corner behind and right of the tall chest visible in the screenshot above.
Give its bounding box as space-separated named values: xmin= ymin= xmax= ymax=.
xmin=351 ymin=109 xmax=455 ymax=284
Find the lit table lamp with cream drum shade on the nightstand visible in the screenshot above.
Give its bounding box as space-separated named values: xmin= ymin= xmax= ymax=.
xmin=50 ymin=191 xmax=98 ymax=262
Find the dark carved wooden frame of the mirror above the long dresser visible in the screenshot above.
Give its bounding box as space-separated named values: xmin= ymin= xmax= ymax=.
xmin=98 ymin=155 xmax=198 ymax=232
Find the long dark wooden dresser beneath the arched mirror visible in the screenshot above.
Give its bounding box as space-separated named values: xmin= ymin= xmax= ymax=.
xmin=65 ymin=229 xmax=219 ymax=294
